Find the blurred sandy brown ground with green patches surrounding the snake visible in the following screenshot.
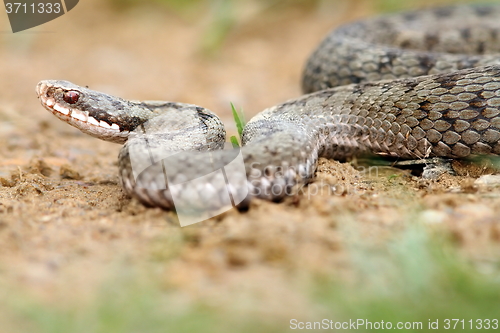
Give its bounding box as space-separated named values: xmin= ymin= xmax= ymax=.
xmin=0 ymin=0 xmax=500 ymax=333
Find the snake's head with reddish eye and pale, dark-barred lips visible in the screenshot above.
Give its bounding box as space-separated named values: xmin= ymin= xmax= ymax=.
xmin=36 ymin=80 xmax=134 ymax=143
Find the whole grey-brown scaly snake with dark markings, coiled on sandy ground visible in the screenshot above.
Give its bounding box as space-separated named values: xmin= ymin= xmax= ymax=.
xmin=37 ymin=5 xmax=500 ymax=209
